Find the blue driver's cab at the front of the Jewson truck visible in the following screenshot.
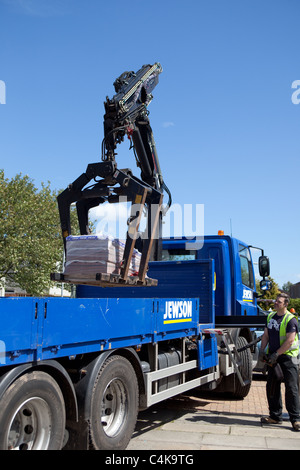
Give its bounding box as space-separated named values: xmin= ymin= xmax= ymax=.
xmin=162 ymin=233 xmax=271 ymax=397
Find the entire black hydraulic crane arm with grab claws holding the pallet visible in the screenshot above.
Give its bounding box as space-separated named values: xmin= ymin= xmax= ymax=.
xmin=57 ymin=63 xmax=171 ymax=283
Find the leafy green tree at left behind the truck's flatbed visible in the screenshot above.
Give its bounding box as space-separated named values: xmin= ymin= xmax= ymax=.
xmin=0 ymin=170 xmax=78 ymax=295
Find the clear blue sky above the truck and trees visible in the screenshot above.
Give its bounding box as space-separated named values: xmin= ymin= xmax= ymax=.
xmin=0 ymin=0 xmax=300 ymax=285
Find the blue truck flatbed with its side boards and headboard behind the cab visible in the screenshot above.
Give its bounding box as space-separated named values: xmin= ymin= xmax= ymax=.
xmin=0 ymin=260 xmax=214 ymax=366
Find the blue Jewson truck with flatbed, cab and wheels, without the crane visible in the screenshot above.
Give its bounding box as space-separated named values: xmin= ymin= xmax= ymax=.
xmin=0 ymin=236 xmax=266 ymax=450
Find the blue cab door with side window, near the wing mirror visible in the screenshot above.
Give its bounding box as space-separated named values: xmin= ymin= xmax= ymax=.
xmin=236 ymin=243 xmax=256 ymax=315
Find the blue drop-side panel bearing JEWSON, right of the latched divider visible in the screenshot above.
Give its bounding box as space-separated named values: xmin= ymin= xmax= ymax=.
xmin=43 ymin=298 xmax=199 ymax=359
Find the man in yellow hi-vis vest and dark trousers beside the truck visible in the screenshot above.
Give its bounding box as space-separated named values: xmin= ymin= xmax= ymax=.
xmin=260 ymin=293 xmax=300 ymax=431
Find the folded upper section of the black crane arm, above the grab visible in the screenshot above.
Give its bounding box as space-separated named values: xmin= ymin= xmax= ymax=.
xmin=102 ymin=63 xmax=170 ymax=197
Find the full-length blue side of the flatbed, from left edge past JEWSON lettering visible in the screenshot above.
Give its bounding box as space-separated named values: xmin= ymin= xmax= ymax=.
xmin=0 ymin=297 xmax=199 ymax=365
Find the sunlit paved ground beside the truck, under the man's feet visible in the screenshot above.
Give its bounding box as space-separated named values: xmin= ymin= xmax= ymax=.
xmin=126 ymin=374 xmax=300 ymax=453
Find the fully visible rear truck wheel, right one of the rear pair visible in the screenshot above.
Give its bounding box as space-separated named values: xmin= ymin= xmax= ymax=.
xmin=90 ymin=356 xmax=138 ymax=450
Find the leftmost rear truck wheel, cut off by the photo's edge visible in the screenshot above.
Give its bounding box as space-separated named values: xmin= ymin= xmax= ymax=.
xmin=0 ymin=371 xmax=65 ymax=450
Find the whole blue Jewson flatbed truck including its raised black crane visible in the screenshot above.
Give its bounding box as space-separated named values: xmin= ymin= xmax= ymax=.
xmin=0 ymin=63 xmax=269 ymax=450
